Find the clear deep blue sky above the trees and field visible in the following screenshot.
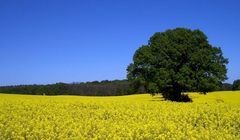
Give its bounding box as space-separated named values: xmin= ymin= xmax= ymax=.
xmin=0 ymin=0 xmax=240 ymax=85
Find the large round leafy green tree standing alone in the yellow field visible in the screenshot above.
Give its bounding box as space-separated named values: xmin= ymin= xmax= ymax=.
xmin=127 ymin=28 xmax=228 ymax=101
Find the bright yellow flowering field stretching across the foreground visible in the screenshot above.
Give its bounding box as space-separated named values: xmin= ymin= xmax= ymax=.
xmin=0 ymin=91 xmax=240 ymax=140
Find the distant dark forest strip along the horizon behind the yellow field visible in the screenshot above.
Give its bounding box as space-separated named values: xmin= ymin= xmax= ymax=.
xmin=0 ymin=80 xmax=232 ymax=96
